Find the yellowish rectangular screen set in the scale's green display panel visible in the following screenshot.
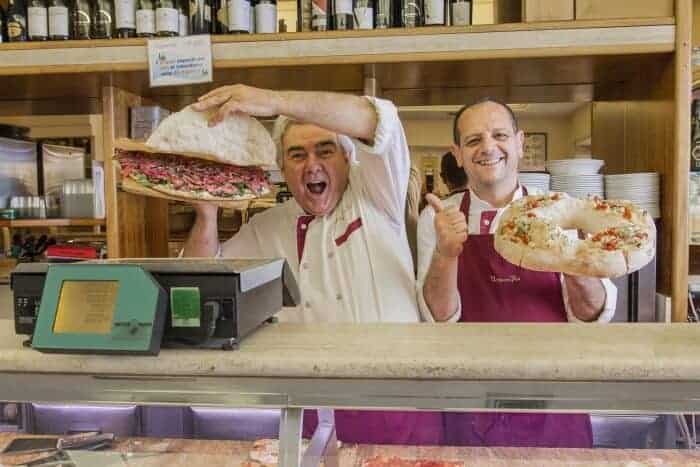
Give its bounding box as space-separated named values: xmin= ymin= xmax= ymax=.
xmin=53 ymin=281 xmax=119 ymax=334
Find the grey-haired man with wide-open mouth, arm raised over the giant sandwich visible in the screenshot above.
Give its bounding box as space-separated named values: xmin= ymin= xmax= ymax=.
xmin=184 ymin=85 xmax=443 ymax=445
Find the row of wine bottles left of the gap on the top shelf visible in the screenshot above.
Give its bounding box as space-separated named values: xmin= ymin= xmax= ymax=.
xmin=0 ymin=0 xmax=284 ymax=42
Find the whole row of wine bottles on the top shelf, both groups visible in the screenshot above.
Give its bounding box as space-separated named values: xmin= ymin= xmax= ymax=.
xmin=0 ymin=0 xmax=472 ymax=42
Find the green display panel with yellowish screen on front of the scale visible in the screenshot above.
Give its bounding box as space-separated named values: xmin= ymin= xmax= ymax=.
xmin=32 ymin=263 xmax=168 ymax=355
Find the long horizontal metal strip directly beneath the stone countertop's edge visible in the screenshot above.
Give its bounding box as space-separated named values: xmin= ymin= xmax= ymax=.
xmin=0 ymin=373 xmax=700 ymax=414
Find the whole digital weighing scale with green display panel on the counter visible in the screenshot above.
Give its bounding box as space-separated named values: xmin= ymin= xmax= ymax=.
xmin=11 ymin=259 xmax=299 ymax=355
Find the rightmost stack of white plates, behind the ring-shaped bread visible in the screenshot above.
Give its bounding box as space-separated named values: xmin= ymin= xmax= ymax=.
xmin=605 ymin=172 xmax=661 ymax=219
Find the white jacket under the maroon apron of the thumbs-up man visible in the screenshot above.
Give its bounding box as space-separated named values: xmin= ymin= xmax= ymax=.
xmin=416 ymin=187 xmax=617 ymax=323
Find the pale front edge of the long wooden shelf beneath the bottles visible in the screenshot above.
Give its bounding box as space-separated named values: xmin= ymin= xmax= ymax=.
xmin=0 ymin=18 xmax=675 ymax=76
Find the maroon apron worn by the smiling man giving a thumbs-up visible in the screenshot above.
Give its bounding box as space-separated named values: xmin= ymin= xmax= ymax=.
xmin=445 ymin=188 xmax=593 ymax=448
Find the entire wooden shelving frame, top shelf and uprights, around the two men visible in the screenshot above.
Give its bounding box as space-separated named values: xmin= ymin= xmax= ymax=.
xmin=0 ymin=4 xmax=693 ymax=321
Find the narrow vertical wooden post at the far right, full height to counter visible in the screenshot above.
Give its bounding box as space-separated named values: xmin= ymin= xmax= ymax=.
xmin=670 ymin=0 xmax=693 ymax=322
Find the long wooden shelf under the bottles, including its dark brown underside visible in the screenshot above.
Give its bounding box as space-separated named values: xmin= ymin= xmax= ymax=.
xmin=0 ymin=18 xmax=676 ymax=108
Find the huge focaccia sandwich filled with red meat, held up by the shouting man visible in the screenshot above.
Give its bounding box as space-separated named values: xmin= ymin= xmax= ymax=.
xmin=115 ymin=107 xmax=275 ymax=206
